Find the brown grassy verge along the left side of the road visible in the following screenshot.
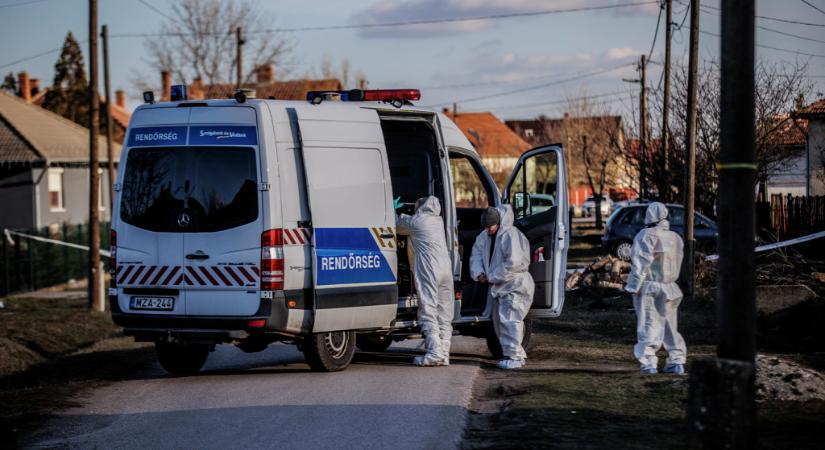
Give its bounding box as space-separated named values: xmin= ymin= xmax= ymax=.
xmin=0 ymin=295 xmax=154 ymax=448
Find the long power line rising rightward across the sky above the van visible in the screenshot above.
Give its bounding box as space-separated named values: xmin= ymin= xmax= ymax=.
xmin=109 ymin=0 xmax=658 ymax=38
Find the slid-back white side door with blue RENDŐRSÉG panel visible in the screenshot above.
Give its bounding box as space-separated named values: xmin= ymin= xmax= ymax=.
xmin=297 ymin=109 xmax=398 ymax=333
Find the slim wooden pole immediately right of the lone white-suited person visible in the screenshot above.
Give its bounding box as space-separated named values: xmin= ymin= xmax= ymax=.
xmin=683 ymin=0 xmax=700 ymax=299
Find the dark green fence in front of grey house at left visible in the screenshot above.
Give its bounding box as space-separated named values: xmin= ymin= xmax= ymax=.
xmin=0 ymin=223 xmax=109 ymax=296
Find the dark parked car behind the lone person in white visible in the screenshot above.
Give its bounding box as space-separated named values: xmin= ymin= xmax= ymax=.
xmin=602 ymin=203 xmax=719 ymax=261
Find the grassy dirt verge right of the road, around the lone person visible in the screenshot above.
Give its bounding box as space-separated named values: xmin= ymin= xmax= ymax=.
xmin=462 ymin=290 xmax=825 ymax=449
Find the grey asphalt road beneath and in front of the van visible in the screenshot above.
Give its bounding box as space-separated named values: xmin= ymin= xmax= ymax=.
xmin=23 ymin=336 xmax=487 ymax=449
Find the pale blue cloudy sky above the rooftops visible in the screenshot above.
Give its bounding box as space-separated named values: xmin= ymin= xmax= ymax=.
xmin=0 ymin=0 xmax=825 ymax=119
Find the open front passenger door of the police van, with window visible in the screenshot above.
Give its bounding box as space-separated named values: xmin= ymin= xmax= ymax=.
xmin=502 ymin=145 xmax=570 ymax=317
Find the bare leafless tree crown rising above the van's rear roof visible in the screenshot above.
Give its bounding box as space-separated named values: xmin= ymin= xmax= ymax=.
xmin=134 ymin=0 xmax=294 ymax=89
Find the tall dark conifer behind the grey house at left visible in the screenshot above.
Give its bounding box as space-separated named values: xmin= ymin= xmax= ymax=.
xmin=43 ymin=31 xmax=89 ymax=127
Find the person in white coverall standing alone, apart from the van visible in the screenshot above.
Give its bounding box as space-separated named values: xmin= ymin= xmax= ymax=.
xmin=625 ymin=202 xmax=687 ymax=375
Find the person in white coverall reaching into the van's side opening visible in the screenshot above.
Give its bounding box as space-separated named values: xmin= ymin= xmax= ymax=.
xmin=395 ymin=196 xmax=454 ymax=366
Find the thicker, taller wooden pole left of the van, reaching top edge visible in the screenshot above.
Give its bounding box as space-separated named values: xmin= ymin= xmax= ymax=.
xmin=88 ymin=0 xmax=103 ymax=311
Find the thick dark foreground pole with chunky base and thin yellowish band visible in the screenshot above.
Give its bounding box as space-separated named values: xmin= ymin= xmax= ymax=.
xmin=688 ymin=0 xmax=756 ymax=449
